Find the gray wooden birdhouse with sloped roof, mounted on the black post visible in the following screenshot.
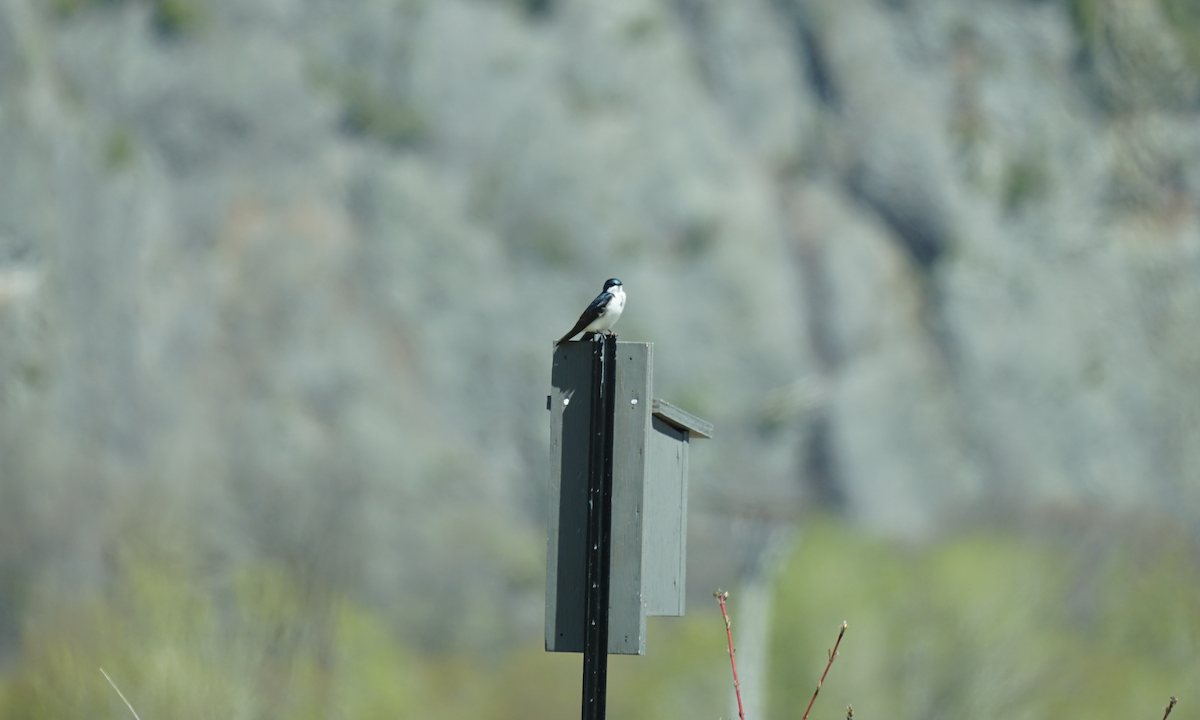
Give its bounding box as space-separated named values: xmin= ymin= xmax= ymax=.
xmin=546 ymin=340 xmax=713 ymax=655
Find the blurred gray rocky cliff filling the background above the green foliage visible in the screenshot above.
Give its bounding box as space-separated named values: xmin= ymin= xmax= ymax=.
xmin=0 ymin=0 xmax=1200 ymax=654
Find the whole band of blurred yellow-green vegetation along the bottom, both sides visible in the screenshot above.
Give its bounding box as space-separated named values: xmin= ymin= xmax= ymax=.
xmin=0 ymin=513 xmax=1200 ymax=720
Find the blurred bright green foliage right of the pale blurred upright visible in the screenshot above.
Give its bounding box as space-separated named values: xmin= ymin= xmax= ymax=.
xmin=770 ymin=523 xmax=1200 ymax=719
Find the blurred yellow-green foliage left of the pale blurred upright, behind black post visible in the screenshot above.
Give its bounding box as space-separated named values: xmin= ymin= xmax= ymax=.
xmin=0 ymin=529 xmax=728 ymax=720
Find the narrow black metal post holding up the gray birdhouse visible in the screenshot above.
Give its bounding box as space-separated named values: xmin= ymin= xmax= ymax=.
xmin=583 ymin=335 xmax=617 ymax=720
